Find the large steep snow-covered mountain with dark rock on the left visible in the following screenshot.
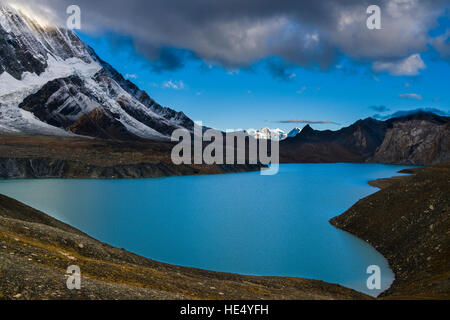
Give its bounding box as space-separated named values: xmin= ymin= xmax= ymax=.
xmin=0 ymin=5 xmax=193 ymax=139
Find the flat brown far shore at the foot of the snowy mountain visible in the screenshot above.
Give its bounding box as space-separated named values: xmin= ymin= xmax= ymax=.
xmin=0 ymin=136 xmax=261 ymax=178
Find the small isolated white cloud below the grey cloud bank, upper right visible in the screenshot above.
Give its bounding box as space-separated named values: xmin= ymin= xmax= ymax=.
xmin=372 ymin=53 xmax=426 ymax=76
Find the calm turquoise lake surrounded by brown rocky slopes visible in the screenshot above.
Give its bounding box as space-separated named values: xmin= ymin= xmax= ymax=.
xmin=0 ymin=164 xmax=414 ymax=296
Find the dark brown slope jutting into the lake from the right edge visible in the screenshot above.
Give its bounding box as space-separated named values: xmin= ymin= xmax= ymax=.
xmin=331 ymin=163 xmax=450 ymax=299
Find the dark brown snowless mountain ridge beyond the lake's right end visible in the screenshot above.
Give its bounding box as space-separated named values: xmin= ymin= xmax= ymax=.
xmin=280 ymin=112 xmax=450 ymax=165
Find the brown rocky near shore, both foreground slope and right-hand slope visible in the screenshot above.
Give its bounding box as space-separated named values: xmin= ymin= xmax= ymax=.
xmin=0 ymin=148 xmax=450 ymax=299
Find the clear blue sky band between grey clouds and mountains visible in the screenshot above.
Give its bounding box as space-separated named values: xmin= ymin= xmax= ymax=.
xmin=80 ymin=33 xmax=450 ymax=130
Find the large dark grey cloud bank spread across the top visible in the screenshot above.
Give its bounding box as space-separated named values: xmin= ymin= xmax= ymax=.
xmin=6 ymin=0 xmax=448 ymax=72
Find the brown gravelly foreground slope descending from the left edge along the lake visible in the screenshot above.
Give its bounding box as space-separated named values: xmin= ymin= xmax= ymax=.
xmin=0 ymin=195 xmax=371 ymax=300
